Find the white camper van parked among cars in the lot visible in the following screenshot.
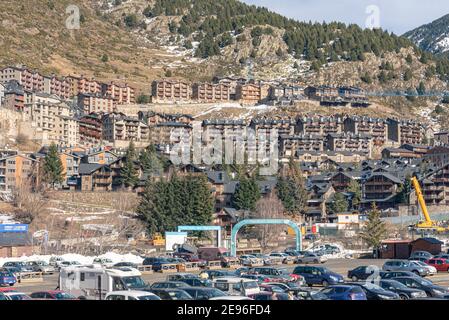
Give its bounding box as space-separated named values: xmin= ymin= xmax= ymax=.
xmin=59 ymin=266 xmax=147 ymax=300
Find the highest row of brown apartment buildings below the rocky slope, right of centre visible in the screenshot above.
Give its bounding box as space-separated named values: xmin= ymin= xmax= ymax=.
xmin=151 ymin=77 xmax=369 ymax=107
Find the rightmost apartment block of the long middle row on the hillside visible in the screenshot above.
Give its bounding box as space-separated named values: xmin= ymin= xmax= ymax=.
xmin=387 ymin=118 xmax=425 ymax=144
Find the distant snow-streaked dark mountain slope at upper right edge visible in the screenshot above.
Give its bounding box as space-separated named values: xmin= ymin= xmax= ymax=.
xmin=404 ymin=14 xmax=449 ymax=54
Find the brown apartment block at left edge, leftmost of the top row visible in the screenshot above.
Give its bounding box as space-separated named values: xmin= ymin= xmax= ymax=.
xmin=0 ymin=66 xmax=45 ymax=92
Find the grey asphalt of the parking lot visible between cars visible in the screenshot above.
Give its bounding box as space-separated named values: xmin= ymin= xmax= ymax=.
xmin=15 ymin=259 xmax=449 ymax=293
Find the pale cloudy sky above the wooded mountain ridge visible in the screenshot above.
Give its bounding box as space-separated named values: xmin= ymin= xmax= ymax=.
xmin=242 ymin=0 xmax=449 ymax=35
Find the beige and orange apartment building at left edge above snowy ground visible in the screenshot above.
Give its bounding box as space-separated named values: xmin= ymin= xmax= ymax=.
xmin=0 ymin=154 xmax=38 ymax=192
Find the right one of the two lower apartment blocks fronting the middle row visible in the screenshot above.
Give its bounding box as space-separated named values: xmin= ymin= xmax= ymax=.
xmin=326 ymin=133 xmax=373 ymax=155
